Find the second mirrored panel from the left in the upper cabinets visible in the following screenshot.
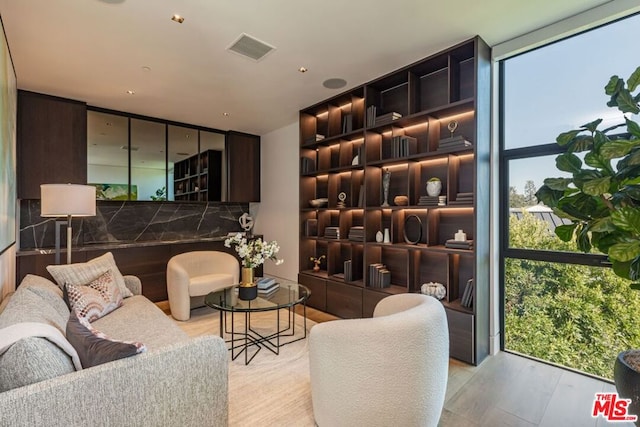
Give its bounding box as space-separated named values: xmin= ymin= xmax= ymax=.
xmin=131 ymin=118 xmax=167 ymax=201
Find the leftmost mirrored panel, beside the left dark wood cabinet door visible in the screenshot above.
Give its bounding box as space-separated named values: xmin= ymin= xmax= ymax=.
xmin=87 ymin=111 xmax=129 ymax=200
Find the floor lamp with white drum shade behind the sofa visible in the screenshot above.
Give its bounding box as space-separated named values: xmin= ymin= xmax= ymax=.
xmin=40 ymin=184 xmax=96 ymax=264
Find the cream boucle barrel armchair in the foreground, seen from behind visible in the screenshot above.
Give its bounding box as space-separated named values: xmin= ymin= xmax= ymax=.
xmin=309 ymin=294 xmax=449 ymax=427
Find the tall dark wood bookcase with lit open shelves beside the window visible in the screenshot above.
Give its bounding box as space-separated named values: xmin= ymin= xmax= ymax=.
xmin=299 ymin=37 xmax=490 ymax=364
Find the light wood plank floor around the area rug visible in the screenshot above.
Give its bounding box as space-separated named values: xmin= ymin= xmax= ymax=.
xmin=158 ymin=302 xmax=633 ymax=427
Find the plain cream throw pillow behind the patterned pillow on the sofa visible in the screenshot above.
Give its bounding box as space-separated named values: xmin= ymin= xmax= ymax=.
xmin=47 ymin=252 xmax=133 ymax=298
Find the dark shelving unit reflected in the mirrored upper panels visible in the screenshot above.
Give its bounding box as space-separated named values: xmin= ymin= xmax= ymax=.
xmin=173 ymin=150 xmax=222 ymax=201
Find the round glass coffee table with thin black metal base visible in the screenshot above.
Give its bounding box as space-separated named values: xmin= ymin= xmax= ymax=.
xmin=204 ymin=279 xmax=311 ymax=365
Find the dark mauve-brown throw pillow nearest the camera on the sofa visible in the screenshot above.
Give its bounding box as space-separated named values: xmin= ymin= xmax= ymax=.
xmin=67 ymin=311 xmax=147 ymax=368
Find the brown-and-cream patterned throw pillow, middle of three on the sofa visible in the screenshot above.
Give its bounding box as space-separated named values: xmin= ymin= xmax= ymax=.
xmin=64 ymin=270 xmax=122 ymax=322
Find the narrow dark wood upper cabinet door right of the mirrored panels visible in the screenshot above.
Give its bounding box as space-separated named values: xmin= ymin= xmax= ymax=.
xmin=225 ymin=131 xmax=260 ymax=203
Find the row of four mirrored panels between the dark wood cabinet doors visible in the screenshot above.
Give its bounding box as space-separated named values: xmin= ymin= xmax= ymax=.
xmin=87 ymin=109 xmax=227 ymax=201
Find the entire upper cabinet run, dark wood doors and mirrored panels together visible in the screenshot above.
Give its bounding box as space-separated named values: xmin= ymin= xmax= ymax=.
xmin=17 ymin=97 xmax=260 ymax=202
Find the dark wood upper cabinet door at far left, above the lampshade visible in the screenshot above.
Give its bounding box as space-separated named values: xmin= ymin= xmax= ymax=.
xmin=17 ymin=91 xmax=87 ymax=199
